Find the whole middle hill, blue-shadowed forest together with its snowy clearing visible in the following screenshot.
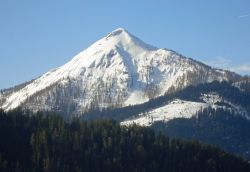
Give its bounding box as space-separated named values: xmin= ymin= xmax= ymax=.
xmin=80 ymin=81 xmax=250 ymax=160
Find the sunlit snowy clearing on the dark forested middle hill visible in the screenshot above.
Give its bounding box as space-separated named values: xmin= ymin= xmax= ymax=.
xmin=121 ymin=93 xmax=250 ymax=126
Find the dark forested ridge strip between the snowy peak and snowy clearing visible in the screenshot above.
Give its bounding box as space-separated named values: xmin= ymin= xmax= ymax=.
xmin=81 ymin=81 xmax=250 ymax=122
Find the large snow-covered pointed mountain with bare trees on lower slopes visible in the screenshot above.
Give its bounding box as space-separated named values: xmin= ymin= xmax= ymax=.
xmin=0 ymin=28 xmax=240 ymax=115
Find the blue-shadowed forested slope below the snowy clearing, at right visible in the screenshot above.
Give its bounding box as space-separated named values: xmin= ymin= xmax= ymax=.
xmin=152 ymin=108 xmax=250 ymax=160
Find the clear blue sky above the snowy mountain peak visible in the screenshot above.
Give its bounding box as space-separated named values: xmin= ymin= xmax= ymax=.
xmin=0 ymin=0 xmax=250 ymax=89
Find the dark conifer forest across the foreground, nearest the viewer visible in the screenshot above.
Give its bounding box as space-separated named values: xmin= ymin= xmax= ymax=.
xmin=0 ymin=110 xmax=250 ymax=172
